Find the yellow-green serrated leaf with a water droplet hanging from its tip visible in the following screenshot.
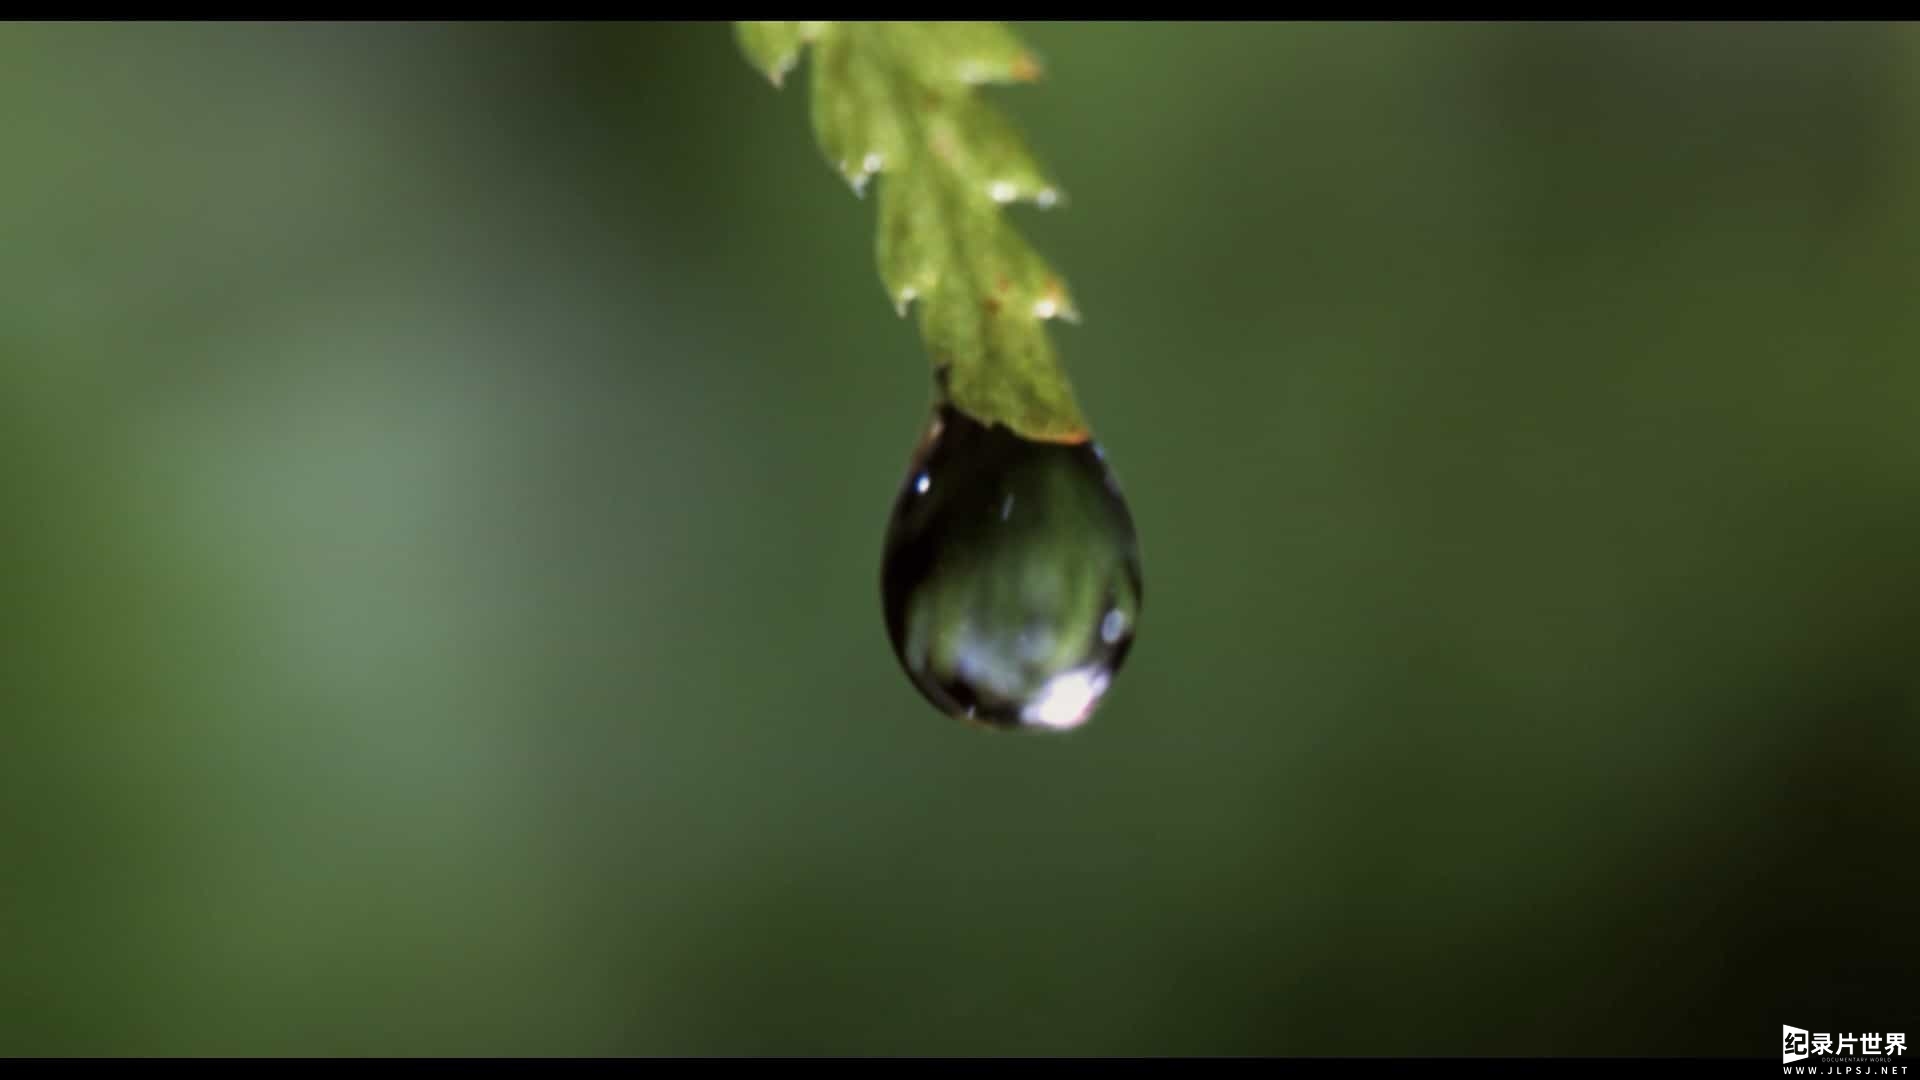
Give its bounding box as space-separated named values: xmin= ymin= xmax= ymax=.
xmin=735 ymin=23 xmax=1089 ymax=442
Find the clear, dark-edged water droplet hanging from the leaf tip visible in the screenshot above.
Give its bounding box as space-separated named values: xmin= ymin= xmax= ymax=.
xmin=881 ymin=407 xmax=1144 ymax=730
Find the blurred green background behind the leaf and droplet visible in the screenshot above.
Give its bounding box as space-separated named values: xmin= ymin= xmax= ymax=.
xmin=0 ymin=23 xmax=1920 ymax=1055
